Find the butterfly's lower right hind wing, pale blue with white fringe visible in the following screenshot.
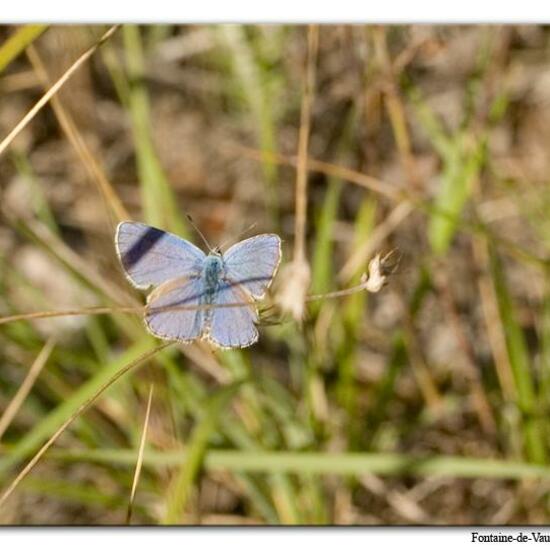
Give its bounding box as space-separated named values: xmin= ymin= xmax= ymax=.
xmin=206 ymin=281 xmax=258 ymax=348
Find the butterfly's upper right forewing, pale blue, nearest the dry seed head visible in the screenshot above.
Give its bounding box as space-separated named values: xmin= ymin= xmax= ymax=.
xmin=223 ymin=233 xmax=281 ymax=299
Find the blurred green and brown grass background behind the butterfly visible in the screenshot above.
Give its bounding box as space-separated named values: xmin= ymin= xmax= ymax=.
xmin=0 ymin=25 xmax=550 ymax=525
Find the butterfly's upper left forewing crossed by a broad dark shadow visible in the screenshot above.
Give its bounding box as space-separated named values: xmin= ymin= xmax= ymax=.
xmin=115 ymin=222 xmax=206 ymax=288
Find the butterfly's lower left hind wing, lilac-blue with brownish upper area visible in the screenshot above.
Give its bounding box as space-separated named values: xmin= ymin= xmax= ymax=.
xmin=145 ymin=277 xmax=205 ymax=342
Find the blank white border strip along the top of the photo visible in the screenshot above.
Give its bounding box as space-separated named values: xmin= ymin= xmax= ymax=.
xmin=0 ymin=0 xmax=550 ymax=24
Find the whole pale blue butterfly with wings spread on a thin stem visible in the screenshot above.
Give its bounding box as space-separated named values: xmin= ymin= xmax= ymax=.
xmin=115 ymin=221 xmax=281 ymax=348
